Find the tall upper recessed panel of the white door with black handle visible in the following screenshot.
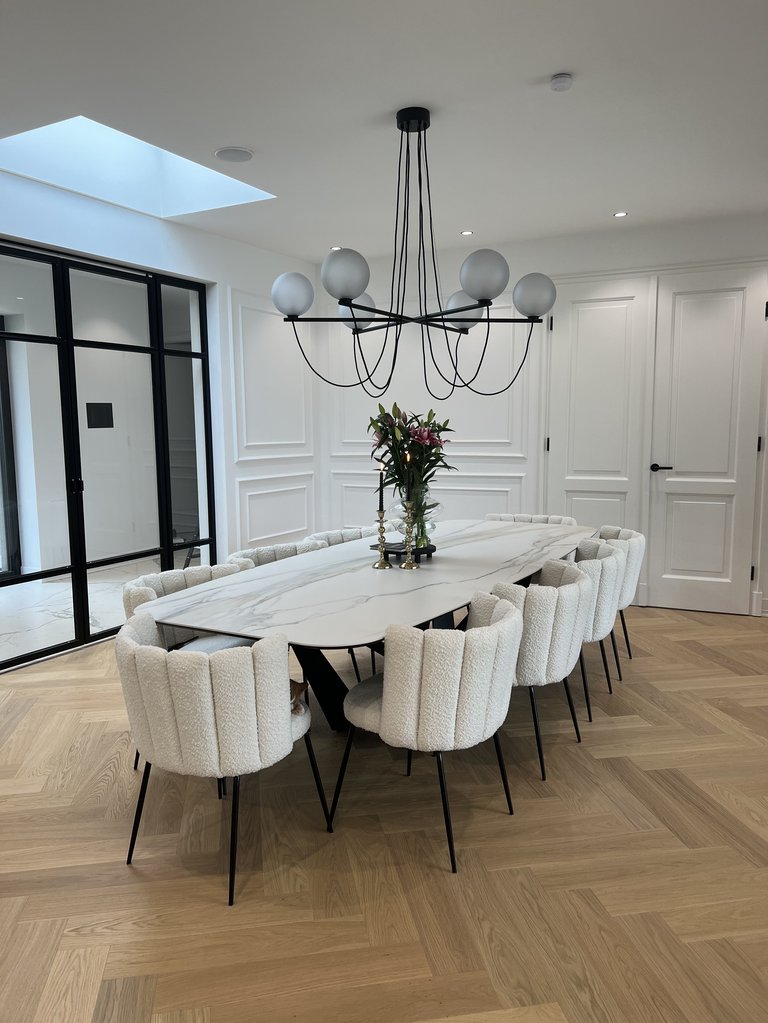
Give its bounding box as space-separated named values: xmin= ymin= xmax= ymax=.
xmin=670 ymin=290 xmax=743 ymax=476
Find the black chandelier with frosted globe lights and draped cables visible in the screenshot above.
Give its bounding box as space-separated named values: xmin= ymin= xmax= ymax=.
xmin=272 ymin=106 xmax=556 ymax=401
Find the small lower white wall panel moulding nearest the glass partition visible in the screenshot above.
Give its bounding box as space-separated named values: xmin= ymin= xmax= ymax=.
xmin=237 ymin=473 xmax=314 ymax=547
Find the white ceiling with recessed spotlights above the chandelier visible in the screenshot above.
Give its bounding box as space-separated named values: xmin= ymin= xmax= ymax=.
xmin=0 ymin=0 xmax=768 ymax=261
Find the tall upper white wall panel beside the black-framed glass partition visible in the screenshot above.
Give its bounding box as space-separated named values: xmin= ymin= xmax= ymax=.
xmin=232 ymin=292 xmax=312 ymax=460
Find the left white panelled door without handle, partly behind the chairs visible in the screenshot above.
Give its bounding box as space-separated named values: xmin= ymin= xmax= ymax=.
xmin=546 ymin=277 xmax=653 ymax=544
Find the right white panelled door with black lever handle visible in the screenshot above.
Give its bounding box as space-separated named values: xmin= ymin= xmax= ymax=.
xmin=646 ymin=268 xmax=766 ymax=614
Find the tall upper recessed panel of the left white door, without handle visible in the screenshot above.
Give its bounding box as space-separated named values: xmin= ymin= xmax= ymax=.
xmin=568 ymin=299 xmax=632 ymax=476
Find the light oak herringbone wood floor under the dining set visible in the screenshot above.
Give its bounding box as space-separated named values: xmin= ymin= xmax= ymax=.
xmin=0 ymin=609 xmax=768 ymax=1023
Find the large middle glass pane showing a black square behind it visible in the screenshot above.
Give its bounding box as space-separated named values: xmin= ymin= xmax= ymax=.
xmin=75 ymin=348 xmax=160 ymax=562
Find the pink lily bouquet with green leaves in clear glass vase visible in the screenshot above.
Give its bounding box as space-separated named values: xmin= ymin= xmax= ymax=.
xmin=368 ymin=405 xmax=455 ymax=547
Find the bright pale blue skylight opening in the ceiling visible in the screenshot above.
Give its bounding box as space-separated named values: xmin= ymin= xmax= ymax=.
xmin=0 ymin=117 xmax=275 ymax=217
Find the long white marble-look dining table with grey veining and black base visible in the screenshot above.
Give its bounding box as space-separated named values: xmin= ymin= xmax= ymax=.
xmin=140 ymin=520 xmax=595 ymax=727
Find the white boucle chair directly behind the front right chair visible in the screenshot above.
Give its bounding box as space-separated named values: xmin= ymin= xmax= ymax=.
xmin=492 ymin=561 xmax=593 ymax=782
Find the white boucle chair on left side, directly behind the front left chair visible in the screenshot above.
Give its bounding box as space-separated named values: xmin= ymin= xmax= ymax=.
xmin=123 ymin=565 xmax=252 ymax=769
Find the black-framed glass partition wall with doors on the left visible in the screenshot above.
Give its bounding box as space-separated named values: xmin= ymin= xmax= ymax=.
xmin=0 ymin=244 xmax=216 ymax=668
